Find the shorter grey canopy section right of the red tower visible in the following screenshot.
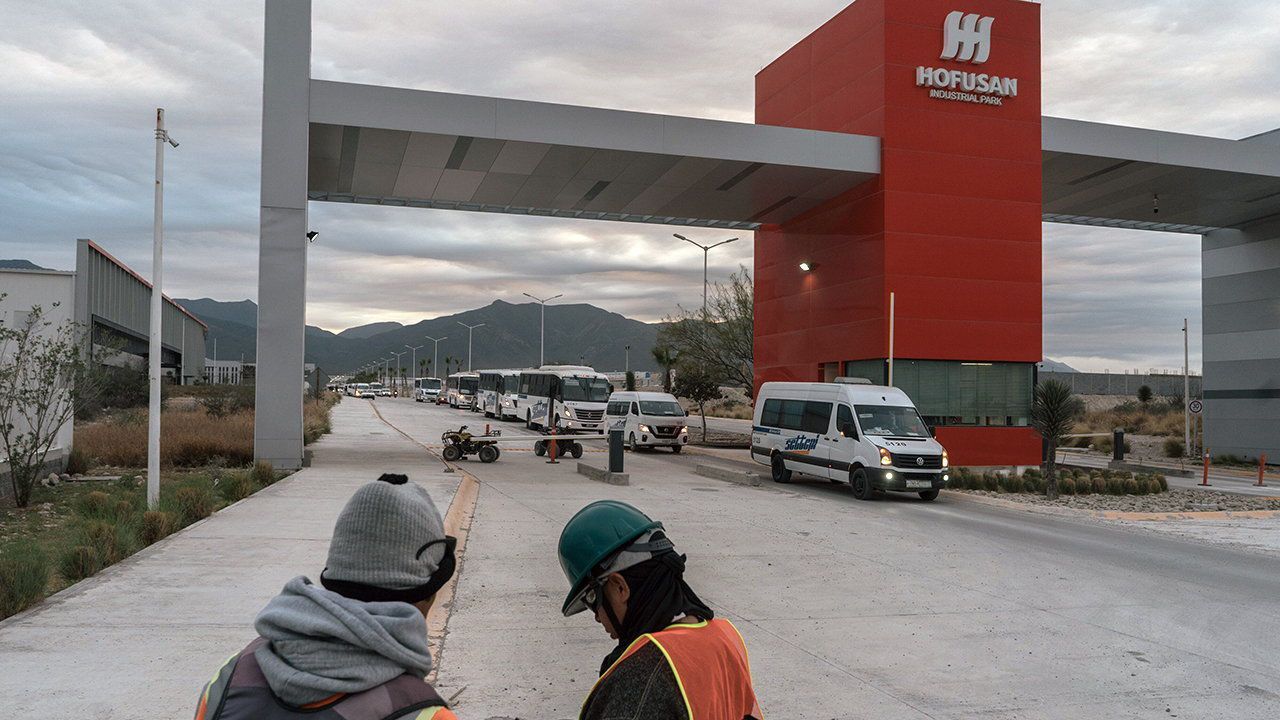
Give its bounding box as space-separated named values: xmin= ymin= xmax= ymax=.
xmin=1042 ymin=118 xmax=1280 ymax=233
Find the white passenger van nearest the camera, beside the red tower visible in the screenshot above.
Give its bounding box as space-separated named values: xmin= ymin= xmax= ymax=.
xmin=751 ymin=378 xmax=950 ymax=500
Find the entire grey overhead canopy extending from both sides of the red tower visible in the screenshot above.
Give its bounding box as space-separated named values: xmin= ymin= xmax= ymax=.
xmin=308 ymin=81 xmax=1280 ymax=233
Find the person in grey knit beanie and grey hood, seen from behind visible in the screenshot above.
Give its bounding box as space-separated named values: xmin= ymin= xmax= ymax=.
xmin=196 ymin=474 xmax=456 ymax=720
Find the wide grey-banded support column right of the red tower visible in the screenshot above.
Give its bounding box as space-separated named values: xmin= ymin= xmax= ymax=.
xmin=1201 ymin=212 xmax=1280 ymax=459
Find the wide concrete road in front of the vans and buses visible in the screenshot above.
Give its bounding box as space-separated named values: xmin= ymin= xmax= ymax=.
xmin=379 ymin=401 xmax=1280 ymax=719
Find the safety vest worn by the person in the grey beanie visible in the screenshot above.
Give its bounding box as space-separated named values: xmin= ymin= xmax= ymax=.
xmin=196 ymin=638 xmax=457 ymax=720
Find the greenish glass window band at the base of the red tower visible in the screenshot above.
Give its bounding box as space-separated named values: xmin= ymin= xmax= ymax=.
xmin=845 ymin=360 xmax=1036 ymax=427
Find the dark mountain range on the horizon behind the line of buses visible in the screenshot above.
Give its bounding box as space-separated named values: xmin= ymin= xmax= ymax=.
xmin=177 ymin=297 xmax=659 ymax=373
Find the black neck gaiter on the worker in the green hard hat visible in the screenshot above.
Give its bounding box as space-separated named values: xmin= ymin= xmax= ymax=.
xmin=600 ymin=552 xmax=716 ymax=675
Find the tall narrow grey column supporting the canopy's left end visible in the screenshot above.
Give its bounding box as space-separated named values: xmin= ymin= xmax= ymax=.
xmin=253 ymin=0 xmax=311 ymax=469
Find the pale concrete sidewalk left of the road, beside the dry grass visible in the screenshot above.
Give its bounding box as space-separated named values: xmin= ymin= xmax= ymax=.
xmin=0 ymin=398 xmax=458 ymax=720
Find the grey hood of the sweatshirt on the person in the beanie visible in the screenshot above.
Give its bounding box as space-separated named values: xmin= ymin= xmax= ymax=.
xmin=255 ymin=577 xmax=431 ymax=707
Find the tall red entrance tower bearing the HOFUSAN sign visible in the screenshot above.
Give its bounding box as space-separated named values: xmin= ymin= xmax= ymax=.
xmin=755 ymin=0 xmax=1042 ymax=465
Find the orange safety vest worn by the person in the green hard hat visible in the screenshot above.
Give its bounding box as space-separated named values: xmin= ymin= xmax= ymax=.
xmin=582 ymin=618 xmax=764 ymax=720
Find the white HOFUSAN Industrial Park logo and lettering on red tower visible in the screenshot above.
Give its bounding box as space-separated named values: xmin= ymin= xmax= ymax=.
xmin=915 ymin=10 xmax=1018 ymax=105
